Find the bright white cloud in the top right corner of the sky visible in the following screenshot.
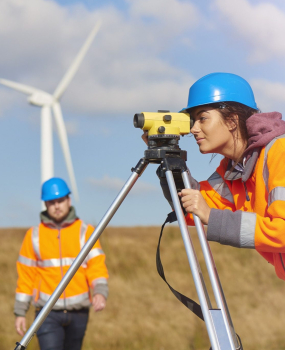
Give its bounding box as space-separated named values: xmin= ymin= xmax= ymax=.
xmin=215 ymin=0 xmax=285 ymax=63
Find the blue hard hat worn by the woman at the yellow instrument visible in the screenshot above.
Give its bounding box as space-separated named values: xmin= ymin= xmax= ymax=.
xmin=182 ymin=73 xmax=258 ymax=111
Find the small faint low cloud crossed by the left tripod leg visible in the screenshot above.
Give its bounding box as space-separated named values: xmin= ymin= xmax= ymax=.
xmin=87 ymin=175 xmax=158 ymax=194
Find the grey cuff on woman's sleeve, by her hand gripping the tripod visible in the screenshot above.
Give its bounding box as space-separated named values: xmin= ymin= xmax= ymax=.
xmin=207 ymin=208 xmax=242 ymax=248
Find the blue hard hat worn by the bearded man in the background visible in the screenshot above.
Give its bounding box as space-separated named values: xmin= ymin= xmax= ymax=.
xmin=42 ymin=177 xmax=70 ymax=202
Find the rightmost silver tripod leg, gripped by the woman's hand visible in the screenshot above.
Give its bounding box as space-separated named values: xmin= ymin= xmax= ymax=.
xmin=182 ymin=171 xmax=239 ymax=349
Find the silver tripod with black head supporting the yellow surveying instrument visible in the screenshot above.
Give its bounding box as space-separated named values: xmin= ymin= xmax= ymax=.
xmin=15 ymin=135 xmax=240 ymax=350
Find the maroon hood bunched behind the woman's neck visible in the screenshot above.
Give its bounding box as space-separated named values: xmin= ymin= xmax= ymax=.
xmin=244 ymin=112 xmax=285 ymax=157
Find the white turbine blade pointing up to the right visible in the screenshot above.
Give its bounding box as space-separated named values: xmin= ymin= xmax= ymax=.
xmin=53 ymin=22 xmax=101 ymax=100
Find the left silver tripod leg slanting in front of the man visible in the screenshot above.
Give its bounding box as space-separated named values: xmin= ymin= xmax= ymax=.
xmin=15 ymin=158 xmax=148 ymax=350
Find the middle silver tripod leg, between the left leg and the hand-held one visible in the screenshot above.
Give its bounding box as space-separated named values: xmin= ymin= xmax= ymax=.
xmin=165 ymin=170 xmax=221 ymax=350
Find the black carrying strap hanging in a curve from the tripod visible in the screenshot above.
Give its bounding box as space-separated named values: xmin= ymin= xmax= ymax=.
xmin=156 ymin=211 xmax=204 ymax=321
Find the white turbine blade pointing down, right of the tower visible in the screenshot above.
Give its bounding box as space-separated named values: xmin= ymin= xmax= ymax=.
xmin=52 ymin=102 xmax=79 ymax=201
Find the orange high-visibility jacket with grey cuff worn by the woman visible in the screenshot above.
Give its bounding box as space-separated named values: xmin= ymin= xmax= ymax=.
xmin=187 ymin=135 xmax=285 ymax=280
